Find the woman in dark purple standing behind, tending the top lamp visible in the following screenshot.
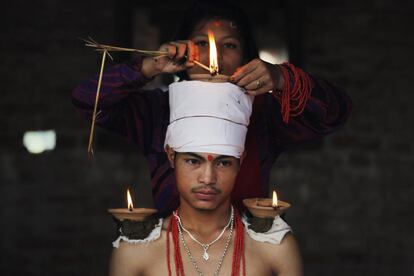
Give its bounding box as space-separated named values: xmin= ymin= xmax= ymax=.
xmin=72 ymin=1 xmax=351 ymax=216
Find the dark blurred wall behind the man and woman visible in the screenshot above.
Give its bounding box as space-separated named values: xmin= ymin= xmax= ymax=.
xmin=0 ymin=0 xmax=414 ymax=276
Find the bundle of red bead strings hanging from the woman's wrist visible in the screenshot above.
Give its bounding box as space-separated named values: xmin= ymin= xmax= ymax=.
xmin=280 ymin=62 xmax=313 ymax=123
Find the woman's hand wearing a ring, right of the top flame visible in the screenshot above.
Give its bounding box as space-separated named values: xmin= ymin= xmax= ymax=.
xmin=230 ymin=58 xmax=284 ymax=96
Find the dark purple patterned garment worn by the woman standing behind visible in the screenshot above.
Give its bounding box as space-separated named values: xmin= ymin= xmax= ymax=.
xmin=72 ymin=58 xmax=351 ymax=216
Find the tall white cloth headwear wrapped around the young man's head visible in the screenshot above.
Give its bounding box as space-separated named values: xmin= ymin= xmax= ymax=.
xmin=164 ymin=81 xmax=254 ymax=158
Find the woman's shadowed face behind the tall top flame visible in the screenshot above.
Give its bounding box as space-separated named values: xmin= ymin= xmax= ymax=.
xmin=187 ymin=20 xmax=243 ymax=76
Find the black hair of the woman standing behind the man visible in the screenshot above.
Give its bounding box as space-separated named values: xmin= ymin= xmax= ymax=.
xmin=174 ymin=0 xmax=259 ymax=79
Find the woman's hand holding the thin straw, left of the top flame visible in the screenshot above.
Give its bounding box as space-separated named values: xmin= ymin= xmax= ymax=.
xmin=142 ymin=40 xmax=198 ymax=78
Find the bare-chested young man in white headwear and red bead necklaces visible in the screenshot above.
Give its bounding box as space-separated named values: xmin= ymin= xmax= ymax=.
xmin=110 ymin=71 xmax=302 ymax=276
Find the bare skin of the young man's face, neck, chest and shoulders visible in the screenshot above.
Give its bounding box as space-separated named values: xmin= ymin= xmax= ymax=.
xmin=110 ymin=149 xmax=302 ymax=276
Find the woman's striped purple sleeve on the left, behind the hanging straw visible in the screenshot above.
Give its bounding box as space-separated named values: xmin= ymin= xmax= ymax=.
xmin=72 ymin=58 xmax=168 ymax=153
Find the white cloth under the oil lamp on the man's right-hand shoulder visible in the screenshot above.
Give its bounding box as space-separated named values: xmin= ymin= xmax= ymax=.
xmin=242 ymin=213 xmax=292 ymax=244
